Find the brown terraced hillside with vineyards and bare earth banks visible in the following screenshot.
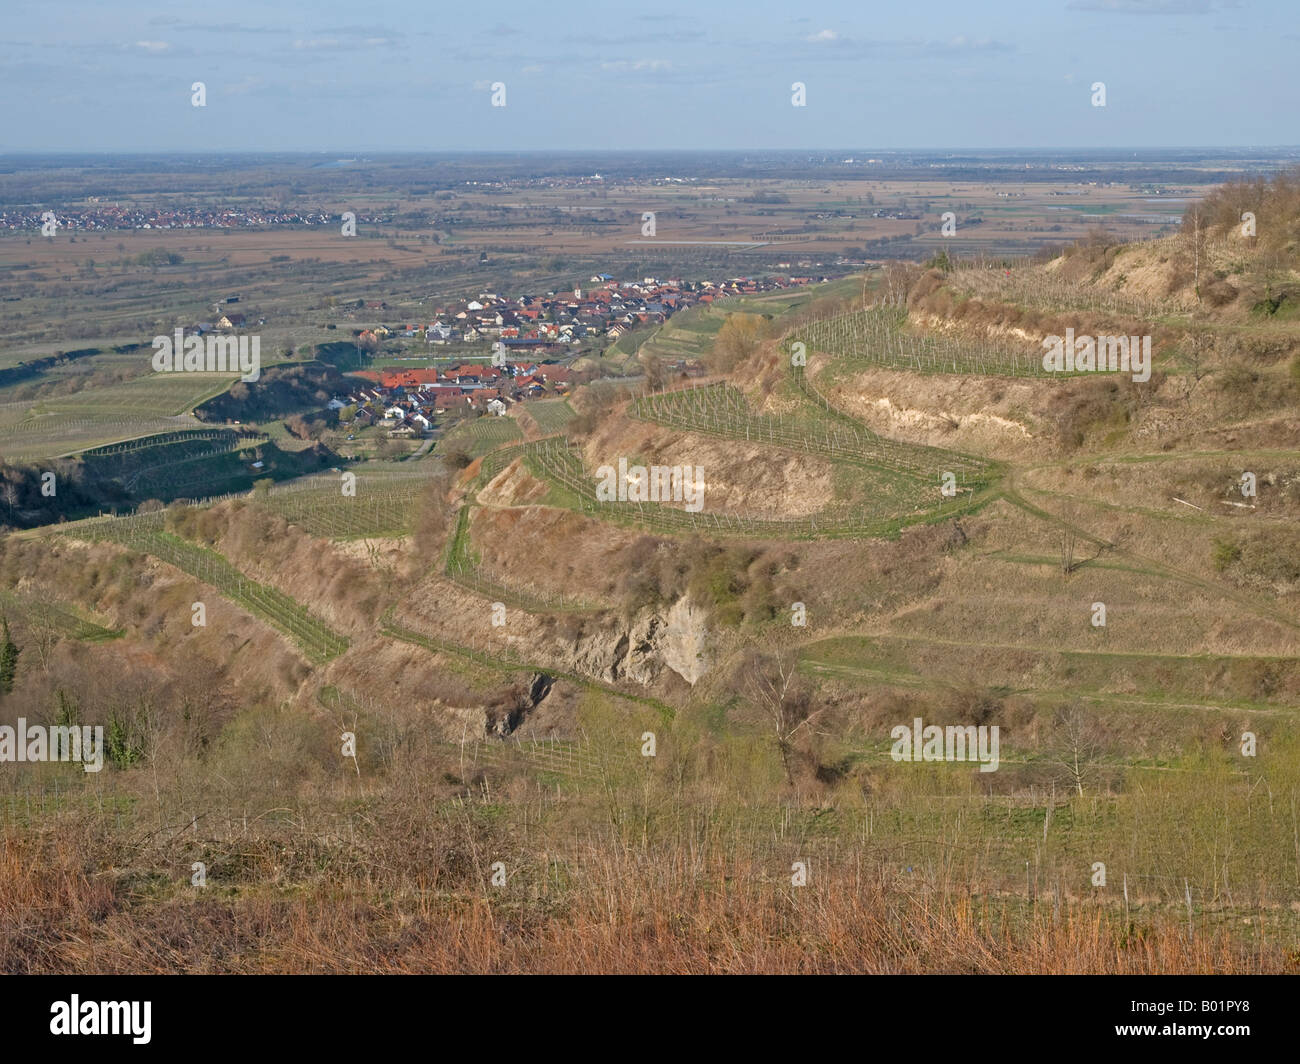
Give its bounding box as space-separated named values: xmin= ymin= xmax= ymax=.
xmin=0 ymin=186 xmax=1300 ymax=972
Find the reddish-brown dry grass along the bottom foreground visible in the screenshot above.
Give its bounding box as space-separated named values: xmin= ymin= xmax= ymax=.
xmin=0 ymin=832 xmax=1279 ymax=974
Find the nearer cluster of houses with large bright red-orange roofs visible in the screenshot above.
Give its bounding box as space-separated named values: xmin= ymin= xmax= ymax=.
xmin=340 ymin=362 xmax=575 ymax=436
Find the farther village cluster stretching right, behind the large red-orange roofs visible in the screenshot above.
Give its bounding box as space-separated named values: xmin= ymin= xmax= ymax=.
xmin=345 ymin=273 xmax=814 ymax=354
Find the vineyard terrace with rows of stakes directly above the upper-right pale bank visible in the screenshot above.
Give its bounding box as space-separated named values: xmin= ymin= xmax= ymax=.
xmin=787 ymin=307 xmax=1062 ymax=377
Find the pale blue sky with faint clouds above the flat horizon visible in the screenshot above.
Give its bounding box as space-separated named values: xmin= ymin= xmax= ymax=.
xmin=0 ymin=0 xmax=1300 ymax=156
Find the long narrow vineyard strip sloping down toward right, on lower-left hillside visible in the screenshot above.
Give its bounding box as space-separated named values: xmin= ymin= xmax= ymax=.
xmin=61 ymin=511 xmax=348 ymax=665
